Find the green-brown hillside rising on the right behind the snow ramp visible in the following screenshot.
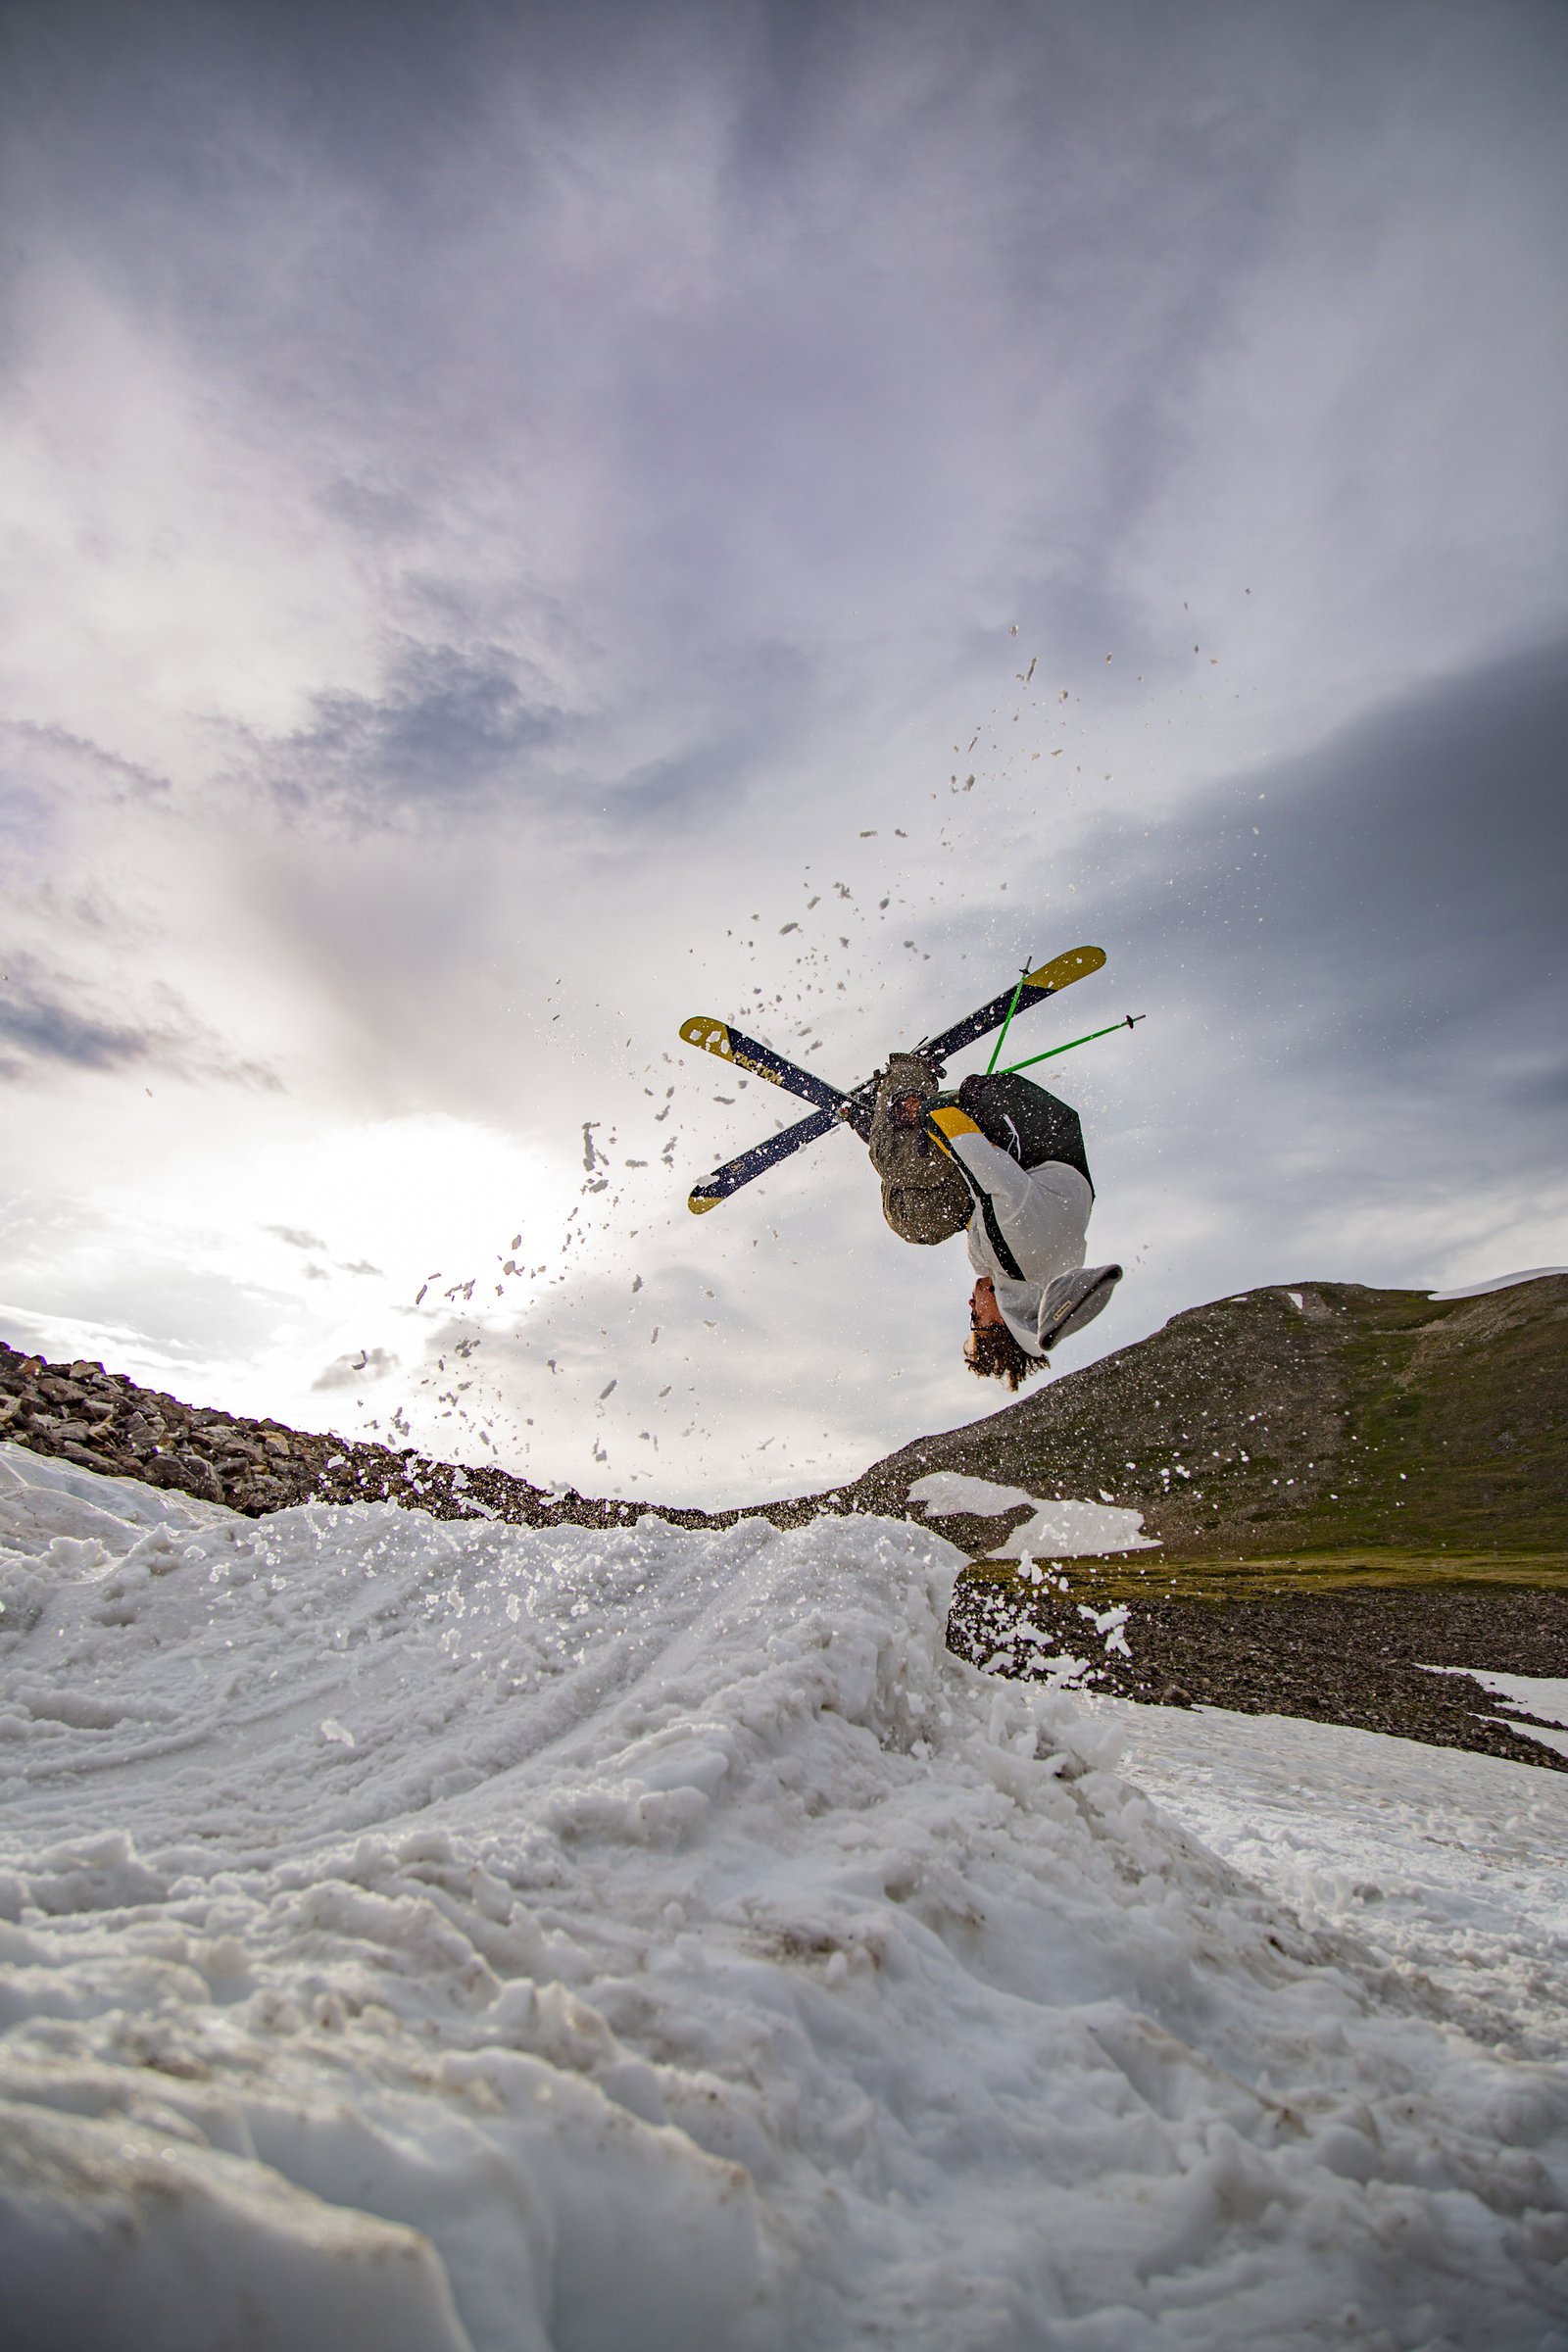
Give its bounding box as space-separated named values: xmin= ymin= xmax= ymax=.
xmin=822 ymin=1275 xmax=1568 ymax=1569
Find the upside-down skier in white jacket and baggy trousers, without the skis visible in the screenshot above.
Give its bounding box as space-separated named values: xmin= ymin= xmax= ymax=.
xmin=870 ymin=1054 xmax=1121 ymax=1388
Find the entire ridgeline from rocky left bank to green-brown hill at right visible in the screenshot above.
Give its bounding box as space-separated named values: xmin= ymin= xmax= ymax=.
xmin=0 ymin=1275 xmax=1568 ymax=1564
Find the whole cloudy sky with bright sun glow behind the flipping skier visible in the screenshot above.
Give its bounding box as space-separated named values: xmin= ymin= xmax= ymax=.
xmin=0 ymin=0 xmax=1568 ymax=1503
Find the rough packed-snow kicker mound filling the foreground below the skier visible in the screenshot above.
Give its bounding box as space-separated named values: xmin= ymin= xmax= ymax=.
xmin=0 ymin=1446 xmax=1568 ymax=2352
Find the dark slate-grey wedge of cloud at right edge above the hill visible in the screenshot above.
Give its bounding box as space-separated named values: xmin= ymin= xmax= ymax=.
xmin=1104 ymin=645 xmax=1568 ymax=1054
